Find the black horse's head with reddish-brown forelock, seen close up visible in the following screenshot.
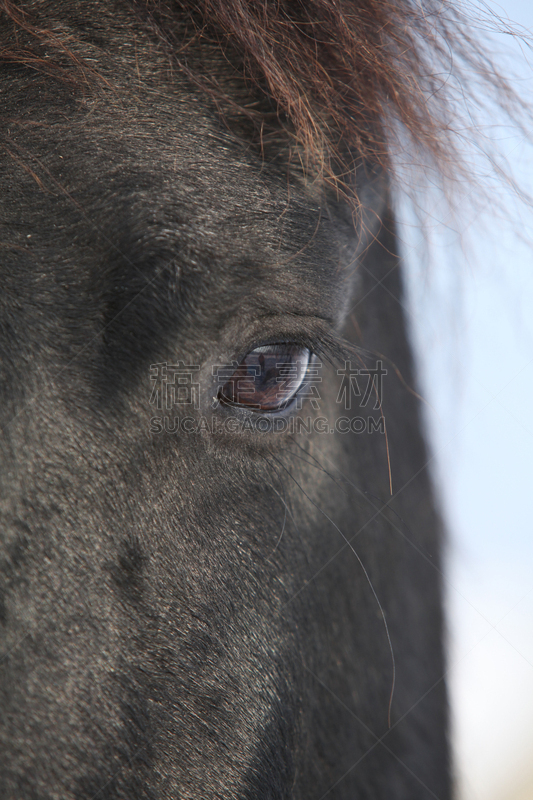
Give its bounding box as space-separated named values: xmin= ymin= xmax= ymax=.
xmin=0 ymin=0 xmax=462 ymax=800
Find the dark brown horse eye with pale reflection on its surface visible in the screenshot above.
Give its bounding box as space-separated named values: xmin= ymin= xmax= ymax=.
xmin=218 ymin=344 xmax=311 ymax=411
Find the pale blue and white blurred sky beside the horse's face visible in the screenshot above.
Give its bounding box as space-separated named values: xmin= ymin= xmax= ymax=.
xmin=404 ymin=0 xmax=533 ymax=800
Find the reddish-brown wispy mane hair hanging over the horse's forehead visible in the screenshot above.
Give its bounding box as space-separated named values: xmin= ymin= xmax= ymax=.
xmin=0 ymin=0 xmax=519 ymax=194
